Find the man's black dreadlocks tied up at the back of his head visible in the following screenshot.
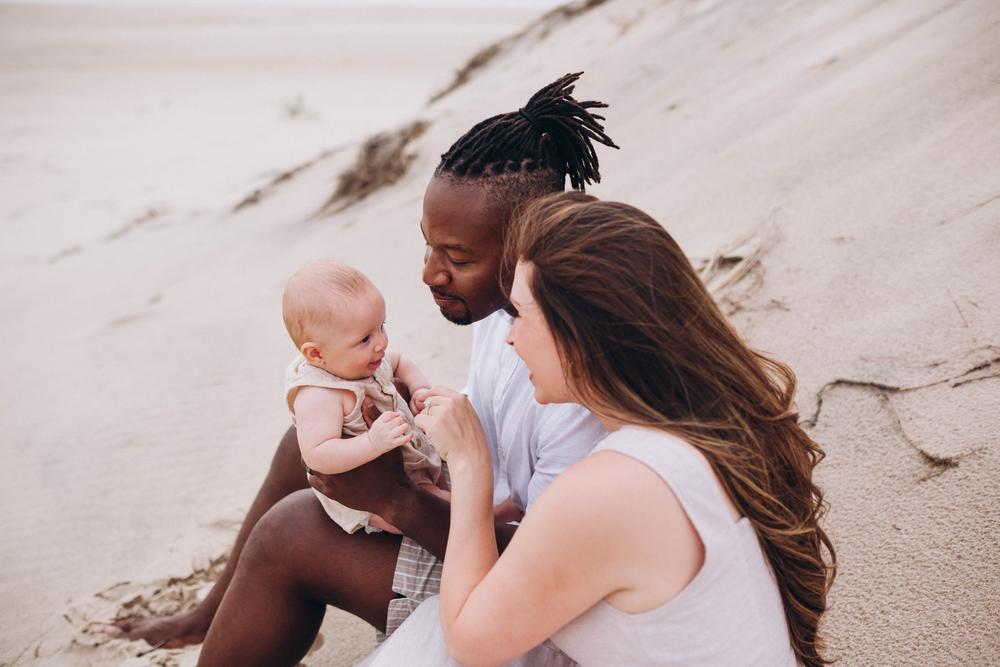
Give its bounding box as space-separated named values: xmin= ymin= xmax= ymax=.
xmin=434 ymin=72 xmax=618 ymax=191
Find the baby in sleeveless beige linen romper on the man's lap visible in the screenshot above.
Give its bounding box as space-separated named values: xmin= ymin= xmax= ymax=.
xmin=282 ymin=262 xmax=447 ymax=534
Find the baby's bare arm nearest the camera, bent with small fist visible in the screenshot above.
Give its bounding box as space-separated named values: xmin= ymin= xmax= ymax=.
xmin=293 ymin=387 xmax=411 ymax=475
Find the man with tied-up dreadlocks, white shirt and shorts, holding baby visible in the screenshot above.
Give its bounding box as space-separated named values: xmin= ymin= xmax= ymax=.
xmin=122 ymin=74 xmax=617 ymax=665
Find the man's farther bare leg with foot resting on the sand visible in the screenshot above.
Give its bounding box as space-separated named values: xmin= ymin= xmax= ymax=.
xmin=109 ymin=428 xmax=308 ymax=648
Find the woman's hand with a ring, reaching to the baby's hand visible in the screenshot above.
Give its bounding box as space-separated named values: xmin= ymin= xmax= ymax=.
xmin=414 ymin=387 xmax=489 ymax=467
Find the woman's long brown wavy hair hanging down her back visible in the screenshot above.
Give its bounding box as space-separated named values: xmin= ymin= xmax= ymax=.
xmin=507 ymin=192 xmax=836 ymax=667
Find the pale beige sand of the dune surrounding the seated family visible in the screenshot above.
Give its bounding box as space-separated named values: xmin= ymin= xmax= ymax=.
xmin=0 ymin=0 xmax=1000 ymax=665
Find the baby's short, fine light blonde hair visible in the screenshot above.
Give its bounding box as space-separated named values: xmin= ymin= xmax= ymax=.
xmin=281 ymin=260 xmax=374 ymax=348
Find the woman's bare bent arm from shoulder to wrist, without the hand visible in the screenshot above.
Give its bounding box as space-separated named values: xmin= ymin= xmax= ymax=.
xmin=441 ymin=444 xmax=705 ymax=666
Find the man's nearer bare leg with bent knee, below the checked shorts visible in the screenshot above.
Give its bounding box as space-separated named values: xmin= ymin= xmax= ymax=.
xmin=198 ymin=491 xmax=400 ymax=667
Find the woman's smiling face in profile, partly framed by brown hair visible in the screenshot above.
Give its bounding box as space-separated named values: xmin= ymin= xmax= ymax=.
xmin=507 ymin=262 xmax=573 ymax=403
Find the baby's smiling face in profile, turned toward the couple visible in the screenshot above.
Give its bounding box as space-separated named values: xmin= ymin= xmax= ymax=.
xmin=310 ymin=287 xmax=389 ymax=380
